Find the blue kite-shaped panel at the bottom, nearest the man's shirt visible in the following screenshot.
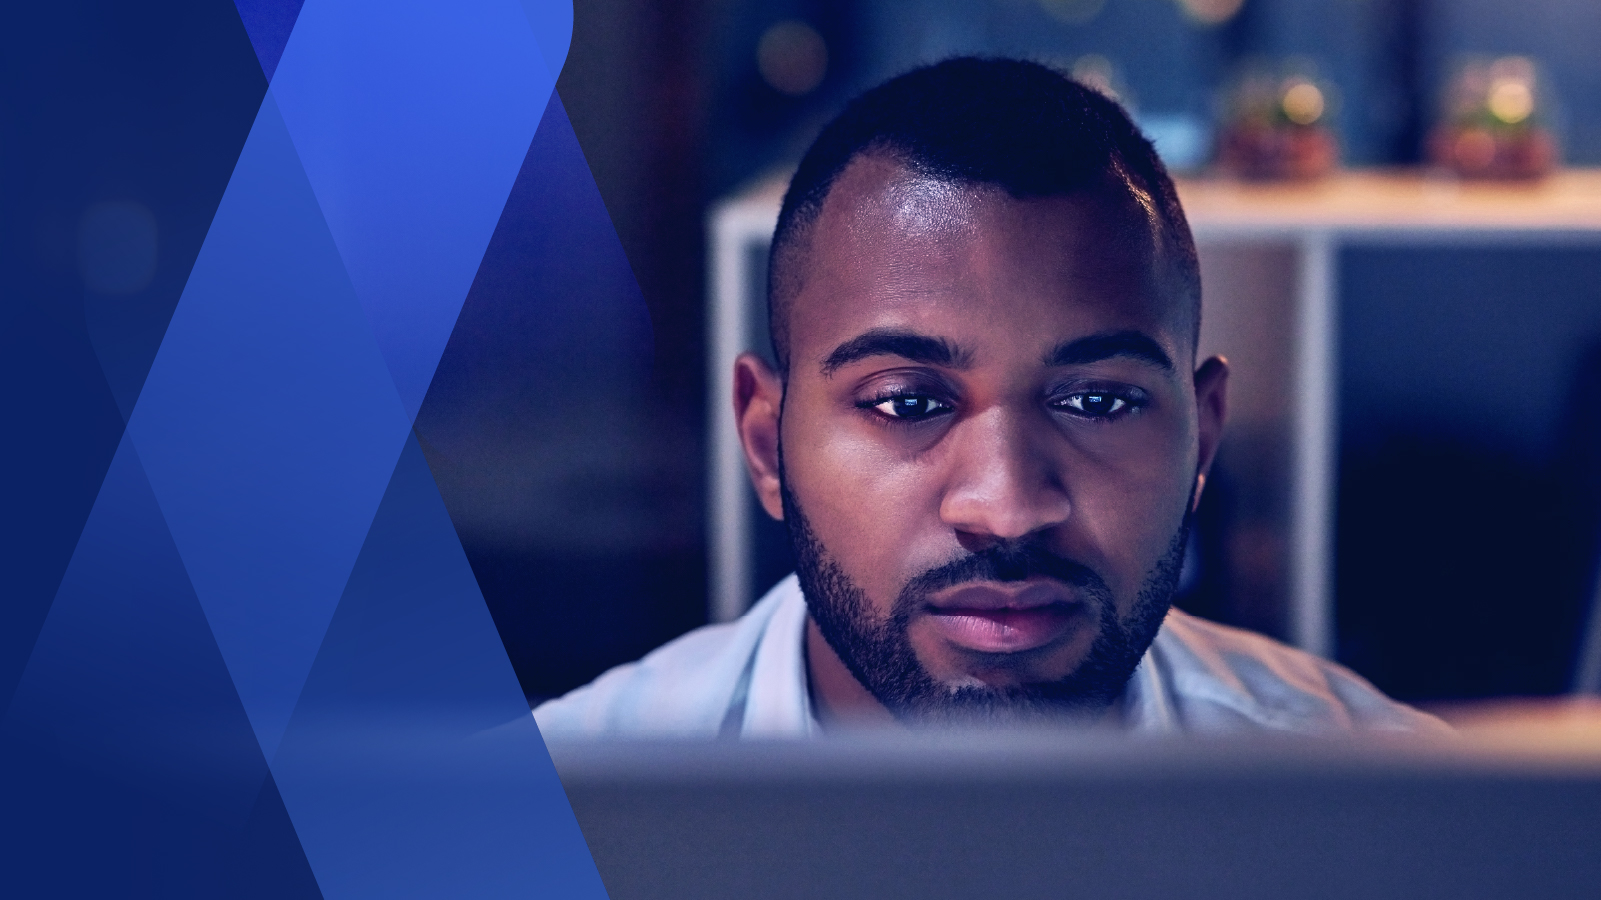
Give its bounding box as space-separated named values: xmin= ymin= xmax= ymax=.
xmin=272 ymin=437 xmax=599 ymax=897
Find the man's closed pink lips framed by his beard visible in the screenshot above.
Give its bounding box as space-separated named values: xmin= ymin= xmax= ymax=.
xmin=925 ymin=581 xmax=1089 ymax=653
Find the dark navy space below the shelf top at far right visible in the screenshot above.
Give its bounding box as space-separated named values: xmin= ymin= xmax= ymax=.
xmin=1335 ymin=243 xmax=1601 ymax=700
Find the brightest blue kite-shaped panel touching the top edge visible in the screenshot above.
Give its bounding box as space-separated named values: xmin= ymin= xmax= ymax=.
xmin=272 ymin=0 xmax=556 ymax=416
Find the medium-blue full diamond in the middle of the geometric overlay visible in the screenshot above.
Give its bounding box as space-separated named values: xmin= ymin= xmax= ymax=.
xmin=128 ymin=93 xmax=410 ymax=759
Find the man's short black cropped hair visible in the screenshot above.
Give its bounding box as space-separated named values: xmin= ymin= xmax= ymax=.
xmin=767 ymin=56 xmax=1201 ymax=375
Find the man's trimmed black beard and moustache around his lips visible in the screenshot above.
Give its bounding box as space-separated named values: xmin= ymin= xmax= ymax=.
xmin=780 ymin=474 xmax=1191 ymax=725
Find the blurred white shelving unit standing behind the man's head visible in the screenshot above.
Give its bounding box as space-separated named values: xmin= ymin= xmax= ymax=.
xmin=706 ymin=170 xmax=1601 ymax=655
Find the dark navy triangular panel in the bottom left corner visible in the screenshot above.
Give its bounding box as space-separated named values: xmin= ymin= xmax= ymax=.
xmin=0 ymin=439 xmax=317 ymax=897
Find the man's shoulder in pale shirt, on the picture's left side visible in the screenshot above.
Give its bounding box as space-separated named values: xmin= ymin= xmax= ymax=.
xmin=533 ymin=580 xmax=789 ymax=737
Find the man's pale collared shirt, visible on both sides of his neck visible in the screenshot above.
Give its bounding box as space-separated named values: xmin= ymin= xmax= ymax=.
xmin=533 ymin=575 xmax=1446 ymax=738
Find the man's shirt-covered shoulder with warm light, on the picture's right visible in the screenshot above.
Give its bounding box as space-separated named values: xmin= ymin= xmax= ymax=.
xmin=1151 ymin=610 xmax=1449 ymax=733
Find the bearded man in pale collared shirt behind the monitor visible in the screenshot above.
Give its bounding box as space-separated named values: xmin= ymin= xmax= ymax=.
xmin=535 ymin=59 xmax=1441 ymax=737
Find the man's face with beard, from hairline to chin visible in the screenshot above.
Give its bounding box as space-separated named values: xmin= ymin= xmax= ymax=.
xmin=739 ymin=155 xmax=1222 ymax=717
